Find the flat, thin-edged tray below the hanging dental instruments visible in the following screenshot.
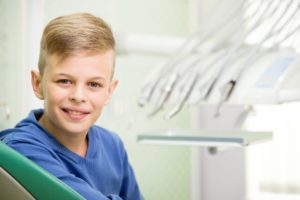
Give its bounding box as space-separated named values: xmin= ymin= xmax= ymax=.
xmin=137 ymin=130 xmax=272 ymax=147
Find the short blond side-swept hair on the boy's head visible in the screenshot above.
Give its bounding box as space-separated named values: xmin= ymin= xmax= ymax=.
xmin=38 ymin=13 xmax=115 ymax=74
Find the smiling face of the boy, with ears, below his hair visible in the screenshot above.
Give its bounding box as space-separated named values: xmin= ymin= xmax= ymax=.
xmin=32 ymin=50 xmax=117 ymax=138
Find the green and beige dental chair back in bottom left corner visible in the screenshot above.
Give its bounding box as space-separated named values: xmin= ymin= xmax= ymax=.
xmin=0 ymin=140 xmax=84 ymax=200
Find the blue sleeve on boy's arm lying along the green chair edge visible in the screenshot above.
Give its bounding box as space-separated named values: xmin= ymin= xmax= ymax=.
xmin=7 ymin=141 xmax=124 ymax=200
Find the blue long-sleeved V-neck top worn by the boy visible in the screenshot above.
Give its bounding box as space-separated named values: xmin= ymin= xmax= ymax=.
xmin=0 ymin=109 xmax=143 ymax=200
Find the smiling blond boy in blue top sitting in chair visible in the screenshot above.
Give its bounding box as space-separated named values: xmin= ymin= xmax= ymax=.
xmin=0 ymin=13 xmax=142 ymax=200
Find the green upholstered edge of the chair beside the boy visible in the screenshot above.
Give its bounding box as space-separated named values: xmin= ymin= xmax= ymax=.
xmin=0 ymin=141 xmax=84 ymax=200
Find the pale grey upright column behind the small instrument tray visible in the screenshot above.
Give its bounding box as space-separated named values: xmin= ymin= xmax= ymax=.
xmin=190 ymin=104 xmax=251 ymax=200
